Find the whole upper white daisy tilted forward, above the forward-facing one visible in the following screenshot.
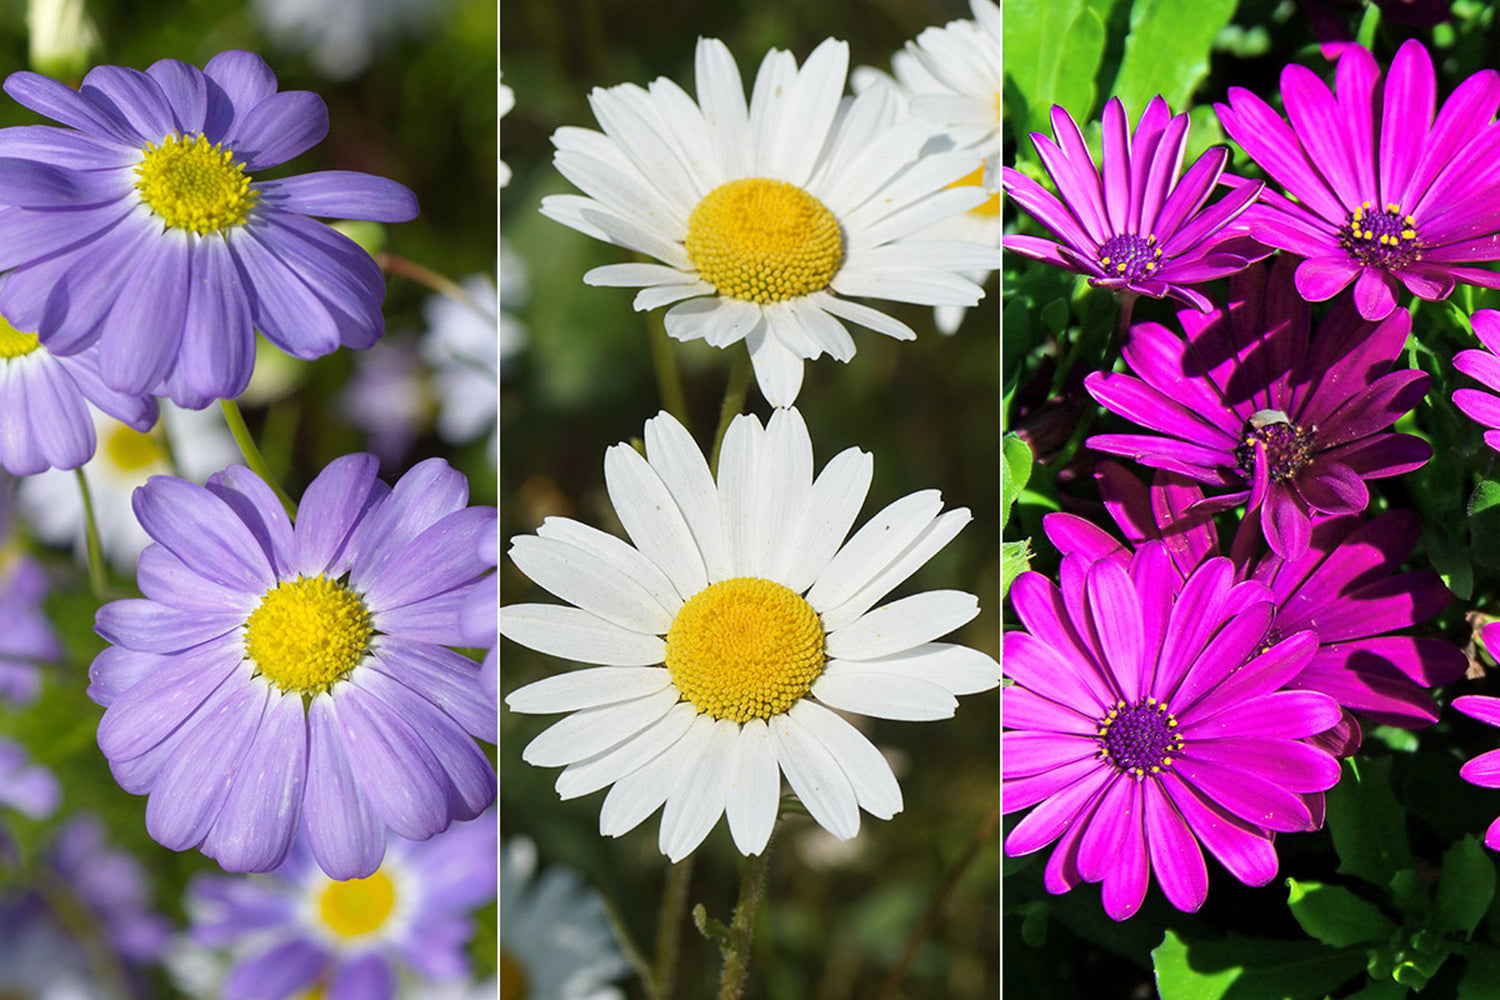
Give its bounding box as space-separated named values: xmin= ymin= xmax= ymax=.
xmin=542 ymin=39 xmax=998 ymax=406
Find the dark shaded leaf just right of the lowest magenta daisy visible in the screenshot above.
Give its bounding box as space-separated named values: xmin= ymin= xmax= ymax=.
xmin=1328 ymin=757 xmax=1412 ymax=888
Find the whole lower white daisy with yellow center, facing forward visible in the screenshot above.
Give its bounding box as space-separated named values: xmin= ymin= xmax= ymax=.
xmin=500 ymin=409 xmax=1001 ymax=862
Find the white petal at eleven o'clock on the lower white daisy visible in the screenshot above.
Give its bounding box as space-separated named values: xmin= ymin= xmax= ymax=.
xmin=605 ymin=444 xmax=708 ymax=600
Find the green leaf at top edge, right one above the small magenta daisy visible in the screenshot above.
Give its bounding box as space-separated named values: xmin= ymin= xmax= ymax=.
xmin=1110 ymin=0 xmax=1235 ymax=118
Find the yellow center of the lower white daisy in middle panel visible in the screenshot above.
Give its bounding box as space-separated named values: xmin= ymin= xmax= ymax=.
xmin=666 ymin=576 xmax=824 ymax=723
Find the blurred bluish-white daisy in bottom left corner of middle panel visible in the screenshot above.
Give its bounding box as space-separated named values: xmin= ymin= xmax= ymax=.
xmin=501 ymin=837 xmax=629 ymax=1000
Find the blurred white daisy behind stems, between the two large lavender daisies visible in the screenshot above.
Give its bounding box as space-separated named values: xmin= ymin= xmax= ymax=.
xmin=17 ymin=399 xmax=240 ymax=574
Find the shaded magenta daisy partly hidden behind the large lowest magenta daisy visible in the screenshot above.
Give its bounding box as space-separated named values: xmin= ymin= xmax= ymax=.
xmin=1043 ymin=462 xmax=1469 ymax=743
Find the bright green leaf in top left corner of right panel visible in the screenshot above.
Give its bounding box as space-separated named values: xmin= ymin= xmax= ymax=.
xmin=1001 ymin=0 xmax=1109 ymax=138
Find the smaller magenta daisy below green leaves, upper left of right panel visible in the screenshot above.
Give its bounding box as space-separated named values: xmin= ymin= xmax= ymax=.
xmin=1002 ymin=97 xmax=1269 ymax=310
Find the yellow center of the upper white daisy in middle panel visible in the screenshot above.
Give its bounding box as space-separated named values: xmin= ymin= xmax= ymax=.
xmin=686 ymin=177 xmax=843 ymax=303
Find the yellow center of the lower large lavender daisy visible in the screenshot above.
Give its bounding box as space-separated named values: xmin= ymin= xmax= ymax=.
xmin=245 ymin=576 xmax=375 ymax=694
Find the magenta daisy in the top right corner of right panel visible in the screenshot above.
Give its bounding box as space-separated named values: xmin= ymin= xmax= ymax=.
xmin=1214 ymin=40 xmax=1500 ymax=319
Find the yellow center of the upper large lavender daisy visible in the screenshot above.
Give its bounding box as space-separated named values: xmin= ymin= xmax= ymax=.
xmin=135 ymin=133 xmax=260 ymax=234
